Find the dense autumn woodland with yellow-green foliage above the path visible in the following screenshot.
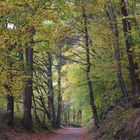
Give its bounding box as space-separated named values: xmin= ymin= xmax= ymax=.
xmin=0 ymin=0 xmax=140 ymax=140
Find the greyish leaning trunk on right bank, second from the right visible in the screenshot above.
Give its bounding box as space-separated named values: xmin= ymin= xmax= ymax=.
xmin=105 ymin=4 xmax=128 ymax=106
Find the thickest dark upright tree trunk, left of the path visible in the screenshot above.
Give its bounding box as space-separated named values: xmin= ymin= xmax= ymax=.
xmin=24 ymin=47 xmax=33 ymax=130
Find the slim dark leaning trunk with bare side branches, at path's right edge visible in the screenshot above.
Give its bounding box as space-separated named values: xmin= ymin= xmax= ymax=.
xmin=83 ymin=8 xmax=99 ymax=128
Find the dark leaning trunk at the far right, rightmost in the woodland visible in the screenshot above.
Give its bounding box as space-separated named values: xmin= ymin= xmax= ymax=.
xmin=121 ymin=0 xmax=140 ymax=99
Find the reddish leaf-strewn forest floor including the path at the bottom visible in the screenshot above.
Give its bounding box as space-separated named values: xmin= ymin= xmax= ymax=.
xmin=3 ymin=127 xmax=90 ymax=140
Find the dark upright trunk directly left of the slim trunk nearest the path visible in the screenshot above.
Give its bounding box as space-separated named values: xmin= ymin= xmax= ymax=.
xmin=47 ymin=52 xmax=56 ymax=128
